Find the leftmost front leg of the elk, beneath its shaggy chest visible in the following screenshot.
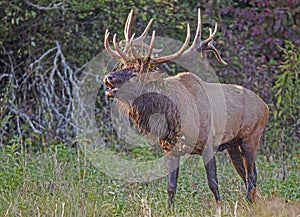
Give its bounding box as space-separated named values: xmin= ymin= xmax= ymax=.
xmin=165 ymin=153 xmax=180 ymax=208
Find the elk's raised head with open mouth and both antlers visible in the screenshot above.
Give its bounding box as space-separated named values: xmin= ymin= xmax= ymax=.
xmin=103 ymin=9 xmax=227 ymax=97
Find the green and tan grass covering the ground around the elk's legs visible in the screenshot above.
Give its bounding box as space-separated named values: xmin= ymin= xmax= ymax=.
xmin=0 ymin=143 xmax=300 ymax=216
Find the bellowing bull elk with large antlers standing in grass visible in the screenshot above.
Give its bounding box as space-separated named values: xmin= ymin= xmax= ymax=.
xmin=103 ymin=10 xmax=268 ymax=206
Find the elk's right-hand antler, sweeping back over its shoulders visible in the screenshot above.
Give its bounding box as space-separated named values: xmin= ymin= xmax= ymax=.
xmin=151 ymin=9 xmax=227 ymax=65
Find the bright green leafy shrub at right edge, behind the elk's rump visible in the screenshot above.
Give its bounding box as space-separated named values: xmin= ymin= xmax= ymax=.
xmin=267 ymin=41 xmax=300 ymax=154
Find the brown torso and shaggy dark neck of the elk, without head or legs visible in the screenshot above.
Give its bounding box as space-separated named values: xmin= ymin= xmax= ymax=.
xmin=117 ymin=73 xmax=268 ymax=157
